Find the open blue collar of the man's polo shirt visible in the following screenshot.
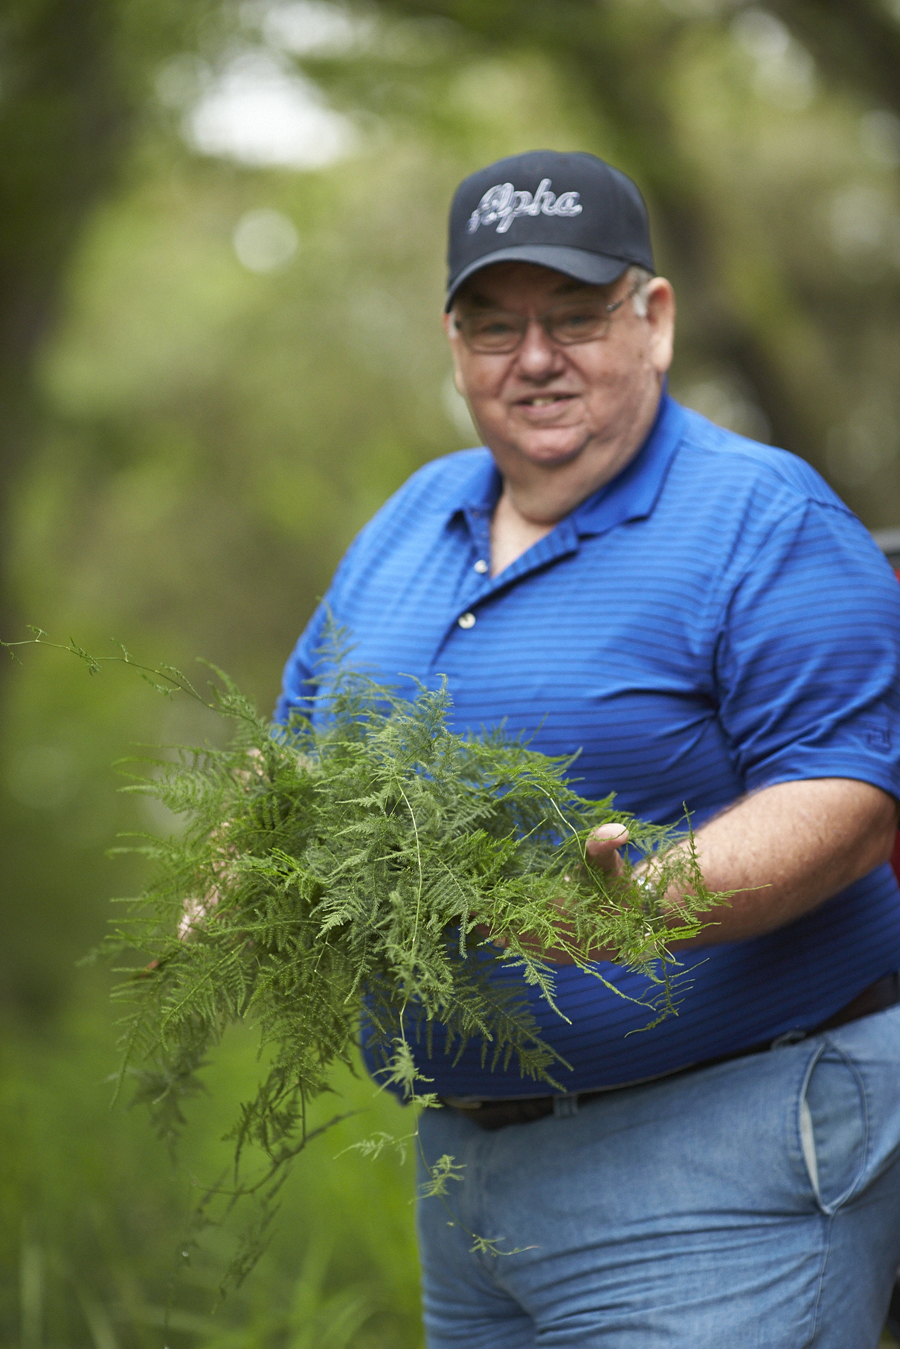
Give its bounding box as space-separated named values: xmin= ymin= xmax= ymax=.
xmin=449 ymin=393 xmax=687 ymax=534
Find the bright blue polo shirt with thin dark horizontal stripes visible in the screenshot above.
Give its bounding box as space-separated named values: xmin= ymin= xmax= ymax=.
xmin=277 ymin=398 xmax=900 ymax=1097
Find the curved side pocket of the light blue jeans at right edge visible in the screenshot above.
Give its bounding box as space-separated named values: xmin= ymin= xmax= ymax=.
xmin=797 ymin=1043 xmax=869 ymax=1214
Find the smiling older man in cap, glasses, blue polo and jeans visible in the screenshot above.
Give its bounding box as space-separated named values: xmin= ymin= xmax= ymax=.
xmin=279 ymin=151 xmax=900 ymax=1349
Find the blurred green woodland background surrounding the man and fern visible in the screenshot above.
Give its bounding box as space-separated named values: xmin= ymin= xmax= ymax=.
xmin=0 ymin=0 xmax=900 ymax=1349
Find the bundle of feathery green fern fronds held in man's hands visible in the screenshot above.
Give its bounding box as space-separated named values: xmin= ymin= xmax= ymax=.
xmin=3 ymin=631 xmax=722 ymax=1279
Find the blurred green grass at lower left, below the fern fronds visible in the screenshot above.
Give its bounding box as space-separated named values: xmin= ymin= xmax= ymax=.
xmin=0 ymin=981 xmax=421 ymax=1349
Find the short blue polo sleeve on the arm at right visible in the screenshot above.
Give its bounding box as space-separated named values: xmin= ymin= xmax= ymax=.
xmin=716 ymin=502 xmax=900 ymax=797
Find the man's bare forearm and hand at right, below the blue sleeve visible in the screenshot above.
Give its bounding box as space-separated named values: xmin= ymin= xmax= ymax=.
xmin=588 ymin=777 xmax=899 ymax=947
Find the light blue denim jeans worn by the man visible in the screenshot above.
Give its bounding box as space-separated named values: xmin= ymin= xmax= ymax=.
xmin=418 ymin=1008 xmax=900 ymax=1349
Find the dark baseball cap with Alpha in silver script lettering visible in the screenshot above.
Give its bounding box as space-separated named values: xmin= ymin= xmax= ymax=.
xmin=445 ymin=150 xmax=656 ymax=309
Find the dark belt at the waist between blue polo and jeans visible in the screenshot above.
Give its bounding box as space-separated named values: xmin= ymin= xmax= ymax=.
xmin=441 ymin=974 xmax=900 ymax=1129
